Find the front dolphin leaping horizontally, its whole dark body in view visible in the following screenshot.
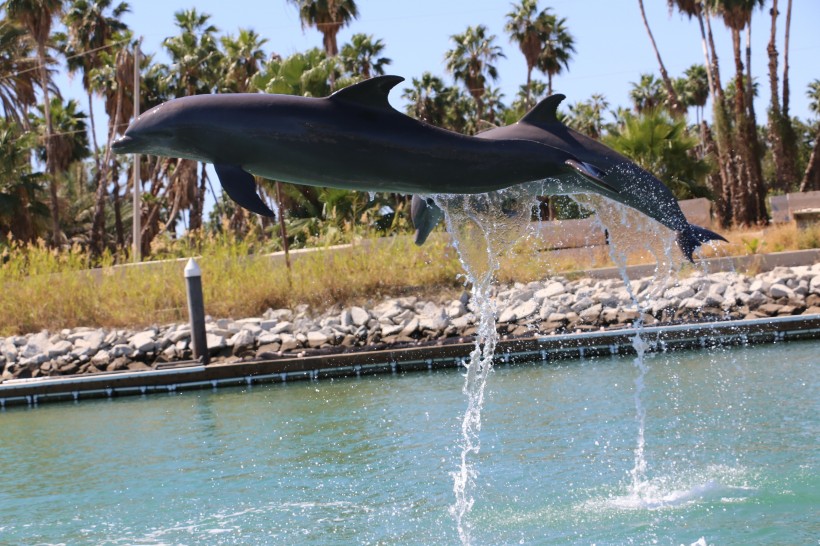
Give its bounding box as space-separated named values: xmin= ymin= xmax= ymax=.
xmin=112 ymin=76 xmax=618 ymax=216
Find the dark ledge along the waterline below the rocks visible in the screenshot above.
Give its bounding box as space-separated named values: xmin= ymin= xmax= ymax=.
xmin=0 ymin=315 xmax=820 ymax=408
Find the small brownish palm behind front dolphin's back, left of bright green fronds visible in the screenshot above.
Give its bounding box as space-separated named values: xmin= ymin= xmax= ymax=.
xmin=220 ymin=29 xmax=268 ymax=93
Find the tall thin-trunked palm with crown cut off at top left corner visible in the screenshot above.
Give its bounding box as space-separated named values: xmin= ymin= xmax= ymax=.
xmin=2 ymin=0 xmax=63 ymax=246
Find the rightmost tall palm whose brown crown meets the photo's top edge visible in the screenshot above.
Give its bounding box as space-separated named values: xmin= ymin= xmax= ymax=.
xmin=713 ymin=0 xmax=767 ymax=225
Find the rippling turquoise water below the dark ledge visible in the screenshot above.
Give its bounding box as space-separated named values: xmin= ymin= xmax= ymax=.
xmin=0 ymin=343 xmax=820 ymax=546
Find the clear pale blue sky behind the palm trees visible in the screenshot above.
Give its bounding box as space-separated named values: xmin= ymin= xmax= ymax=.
xmin=57 ymin=0 xmax=820 ymax=121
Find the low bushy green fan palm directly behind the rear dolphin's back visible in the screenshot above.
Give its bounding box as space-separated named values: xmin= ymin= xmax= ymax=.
xmin=603 ymin=108 xmax=711 ymax=199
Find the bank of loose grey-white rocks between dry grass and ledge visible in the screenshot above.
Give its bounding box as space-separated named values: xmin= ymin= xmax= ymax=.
xmin=0 ymin=263 xmax=820 ymax=382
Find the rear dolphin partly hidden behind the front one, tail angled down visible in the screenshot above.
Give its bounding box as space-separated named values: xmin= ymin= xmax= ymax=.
xmin=411 ymin=94 xmax=726 ymax=261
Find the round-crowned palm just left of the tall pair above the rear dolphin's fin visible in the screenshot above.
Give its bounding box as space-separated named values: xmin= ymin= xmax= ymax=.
xmin=444 ymin=25 xmax=504 ymax=123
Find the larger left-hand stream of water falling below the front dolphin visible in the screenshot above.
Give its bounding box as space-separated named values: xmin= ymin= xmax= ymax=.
xmin=434 ymin=188 xmax=533 ymax=544
